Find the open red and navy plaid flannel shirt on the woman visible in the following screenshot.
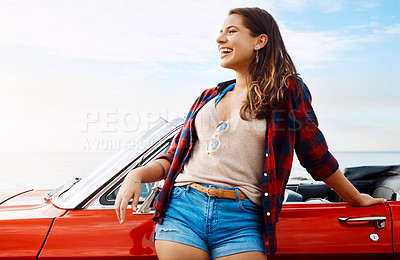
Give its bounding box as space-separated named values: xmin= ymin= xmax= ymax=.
xmin=153 ymin=78 xmax=339 ymax=254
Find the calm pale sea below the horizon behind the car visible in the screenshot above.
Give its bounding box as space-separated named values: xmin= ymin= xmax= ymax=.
xmin=0 ymin=151 xmax=400 ymax=193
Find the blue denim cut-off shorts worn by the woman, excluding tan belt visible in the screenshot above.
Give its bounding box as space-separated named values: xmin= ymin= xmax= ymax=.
xmin=153 ymin=184 xmax=267 ymax=259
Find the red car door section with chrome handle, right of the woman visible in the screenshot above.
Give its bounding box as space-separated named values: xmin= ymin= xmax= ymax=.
xmin=268 ymin=202 xmax=392 ymax=260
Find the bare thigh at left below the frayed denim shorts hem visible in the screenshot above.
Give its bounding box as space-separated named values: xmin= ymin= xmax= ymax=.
xmin=155 ymin=240 xmax=211 ymax=260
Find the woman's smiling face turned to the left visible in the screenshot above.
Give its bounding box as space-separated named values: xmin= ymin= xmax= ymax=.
xmin=217 ymin=14 xmax=257 ymax=73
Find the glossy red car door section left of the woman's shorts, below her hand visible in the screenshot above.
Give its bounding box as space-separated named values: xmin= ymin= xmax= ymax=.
xmin=39 ymin=209 xmax=157 ymax=259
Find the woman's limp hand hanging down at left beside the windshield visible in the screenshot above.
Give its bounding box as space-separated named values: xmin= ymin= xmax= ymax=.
xmin=115 ymin=174 xmax=142 ymax=224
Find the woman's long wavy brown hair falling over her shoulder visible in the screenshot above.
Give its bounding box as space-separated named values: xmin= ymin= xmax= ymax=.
xmin=229 ymin=7 xmax=299 ymax=120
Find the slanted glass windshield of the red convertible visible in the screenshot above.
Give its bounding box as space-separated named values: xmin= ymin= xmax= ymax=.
xmin=53 ymin=118 xmax=182 ymax=208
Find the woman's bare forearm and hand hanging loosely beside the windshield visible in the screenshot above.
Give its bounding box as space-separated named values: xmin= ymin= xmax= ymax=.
xmin=115 ymin=159 xmax=171 ymax=224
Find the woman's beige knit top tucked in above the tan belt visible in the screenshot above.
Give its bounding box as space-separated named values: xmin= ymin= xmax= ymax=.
xmin=175 ymin=97 xmax=266 ymax=206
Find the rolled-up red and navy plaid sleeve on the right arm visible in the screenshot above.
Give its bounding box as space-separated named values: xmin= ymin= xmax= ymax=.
xmin=292 ymin=82 xmax=339 ymax=181
